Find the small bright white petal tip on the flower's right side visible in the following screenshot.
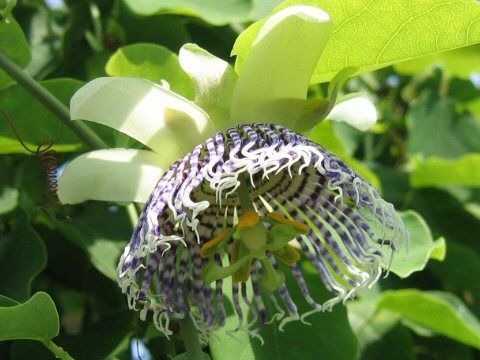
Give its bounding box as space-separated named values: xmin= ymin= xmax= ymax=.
xmin=327 ymin=96 xmax=378 ymax=131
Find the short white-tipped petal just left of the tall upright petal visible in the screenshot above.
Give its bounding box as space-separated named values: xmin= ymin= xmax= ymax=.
xmin=178 ymin=44 xmax=237 ymax=129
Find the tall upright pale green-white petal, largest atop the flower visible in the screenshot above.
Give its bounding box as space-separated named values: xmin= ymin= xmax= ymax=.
xmin=231 ymin=6 xmax=333 ymax=127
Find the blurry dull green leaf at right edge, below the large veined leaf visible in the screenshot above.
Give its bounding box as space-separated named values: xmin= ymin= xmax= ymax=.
xmin=406 ymin=90 xmax=480 ymax=159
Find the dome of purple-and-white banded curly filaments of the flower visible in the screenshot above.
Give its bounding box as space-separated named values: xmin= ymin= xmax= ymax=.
xmin=118 ymin=124 xmax=408 ymax=336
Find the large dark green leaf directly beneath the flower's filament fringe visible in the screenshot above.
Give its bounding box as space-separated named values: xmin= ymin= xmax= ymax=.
xmin=210 ymin=266 xmax=357 ymax=360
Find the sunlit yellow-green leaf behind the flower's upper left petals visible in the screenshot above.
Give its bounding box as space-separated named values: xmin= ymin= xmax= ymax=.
xmin=106 ymin=44 xmax=195 ymax=99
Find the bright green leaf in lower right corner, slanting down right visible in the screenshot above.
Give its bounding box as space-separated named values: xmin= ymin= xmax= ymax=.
xmin=378 ymin=289 xmax=480 ymax=349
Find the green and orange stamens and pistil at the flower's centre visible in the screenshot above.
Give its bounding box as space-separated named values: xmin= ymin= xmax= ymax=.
xmin=200 ymin=178 xmax=309 ymax=291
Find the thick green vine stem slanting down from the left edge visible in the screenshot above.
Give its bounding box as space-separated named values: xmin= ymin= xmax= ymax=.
xmin=0 ymin=51 xmax=107 ymax=149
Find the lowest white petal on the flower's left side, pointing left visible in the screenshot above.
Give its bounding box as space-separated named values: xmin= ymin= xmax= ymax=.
xmin=58 ymin=149 xmax=163 ymax=204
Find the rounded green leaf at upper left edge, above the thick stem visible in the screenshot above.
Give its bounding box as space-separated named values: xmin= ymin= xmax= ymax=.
xmin=0 ymin=17 xmax=31 ymax=88
